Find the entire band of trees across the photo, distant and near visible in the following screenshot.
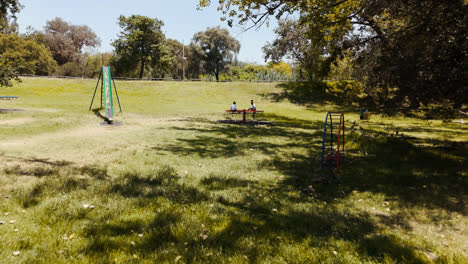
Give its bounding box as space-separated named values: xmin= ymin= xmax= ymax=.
xmin=0 ymin=0 xmax=468 ymax=116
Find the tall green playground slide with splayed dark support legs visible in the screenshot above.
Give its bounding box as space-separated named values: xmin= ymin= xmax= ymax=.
xmin=89 ymin=55 xmax=122 ymax=124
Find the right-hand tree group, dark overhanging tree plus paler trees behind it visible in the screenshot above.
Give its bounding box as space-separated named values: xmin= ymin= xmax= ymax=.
xmin=199 ymin=0 xmax=468 ymax=116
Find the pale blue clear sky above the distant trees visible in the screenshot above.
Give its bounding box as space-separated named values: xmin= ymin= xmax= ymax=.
xmin=18 ymin=0 xmax=277 ymax=64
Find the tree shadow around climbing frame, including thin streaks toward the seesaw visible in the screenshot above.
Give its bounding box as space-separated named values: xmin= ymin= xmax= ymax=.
xmin=149 ymin=115 xmax=468 ymax=214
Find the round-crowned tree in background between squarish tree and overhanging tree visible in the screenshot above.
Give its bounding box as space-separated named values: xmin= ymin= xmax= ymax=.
xmin=193 ymin=27 xmax=240 ymax=81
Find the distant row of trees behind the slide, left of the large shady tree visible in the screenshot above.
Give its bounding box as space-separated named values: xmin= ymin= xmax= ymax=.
xmin=0 ymin=11 xmax=294 ymax=82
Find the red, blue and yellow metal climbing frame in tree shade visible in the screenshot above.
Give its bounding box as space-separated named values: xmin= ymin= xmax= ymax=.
xmin=320 ymin=112 xmax=345 ymax=169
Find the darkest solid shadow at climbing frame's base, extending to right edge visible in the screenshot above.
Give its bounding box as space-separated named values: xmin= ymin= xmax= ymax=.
xmin=266 ymin=125 xmax=468 ymax=215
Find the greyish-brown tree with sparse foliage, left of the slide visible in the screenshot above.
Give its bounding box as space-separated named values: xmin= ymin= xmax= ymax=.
xmin=43 ymin=18 xmax=100 ymax=65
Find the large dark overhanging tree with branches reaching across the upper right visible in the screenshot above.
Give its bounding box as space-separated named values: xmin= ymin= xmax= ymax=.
xmin=200 ymin=0 xmax=468 ymax=112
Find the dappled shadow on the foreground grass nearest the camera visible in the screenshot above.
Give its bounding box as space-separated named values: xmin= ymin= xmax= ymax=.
xmin=81 ymin=170 xmax=432 ymax=263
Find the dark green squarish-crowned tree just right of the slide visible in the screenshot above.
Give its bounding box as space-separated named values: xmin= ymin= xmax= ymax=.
xmin=112 ymin=15 xmax=169 ymax=79
